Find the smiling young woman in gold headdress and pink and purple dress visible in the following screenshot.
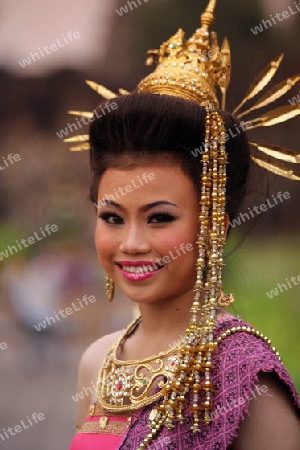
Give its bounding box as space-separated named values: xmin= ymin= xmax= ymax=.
xmin=70 ymin=0 xmax=300 ymax=450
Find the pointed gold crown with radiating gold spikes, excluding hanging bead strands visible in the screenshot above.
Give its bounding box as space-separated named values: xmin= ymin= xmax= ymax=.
xmin=65 ymin=0 xmax=300 ymax=180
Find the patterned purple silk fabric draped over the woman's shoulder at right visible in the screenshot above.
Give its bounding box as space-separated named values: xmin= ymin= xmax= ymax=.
xmin=118 ymin=317 xmax=300 ymax=450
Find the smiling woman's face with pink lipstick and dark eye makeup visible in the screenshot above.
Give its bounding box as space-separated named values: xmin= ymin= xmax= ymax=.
xmin=95 ymin=159 xmax=199 ymax=303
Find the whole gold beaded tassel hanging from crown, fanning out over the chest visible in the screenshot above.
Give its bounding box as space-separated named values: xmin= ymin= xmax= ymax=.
xmin=139 ymin=106 xmax=227 ymax=450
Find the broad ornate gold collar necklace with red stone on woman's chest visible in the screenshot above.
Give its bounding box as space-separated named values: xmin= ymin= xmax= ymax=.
xmin=97 ymin=317 xmax=183 ymax=413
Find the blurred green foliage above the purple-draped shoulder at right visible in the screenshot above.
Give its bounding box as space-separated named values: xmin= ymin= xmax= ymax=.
xmin=224 ymin=236 xmax=300 ymax=389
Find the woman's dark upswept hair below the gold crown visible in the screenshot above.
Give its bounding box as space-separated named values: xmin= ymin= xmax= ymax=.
xmin=90 ymin=93 xmax=250 ymax=220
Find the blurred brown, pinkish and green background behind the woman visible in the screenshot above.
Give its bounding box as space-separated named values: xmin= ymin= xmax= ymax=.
xmin=0 ymin=0 xmax=300 ymax=450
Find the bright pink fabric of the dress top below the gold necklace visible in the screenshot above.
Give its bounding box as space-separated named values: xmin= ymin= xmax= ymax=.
xmin=69 ymin=416 xmax=127 ymax=450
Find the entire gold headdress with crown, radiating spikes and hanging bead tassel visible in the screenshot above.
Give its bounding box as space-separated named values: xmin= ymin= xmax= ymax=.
xmin=66 ymin=0 xmax=300 ymax=449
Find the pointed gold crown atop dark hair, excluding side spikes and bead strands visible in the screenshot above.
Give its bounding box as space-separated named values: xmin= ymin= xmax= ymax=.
xmin=137 ymin=0 xmax=231 ymax=109
